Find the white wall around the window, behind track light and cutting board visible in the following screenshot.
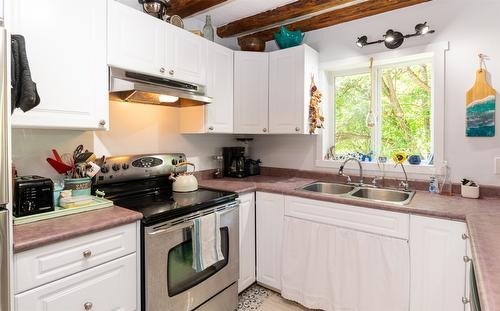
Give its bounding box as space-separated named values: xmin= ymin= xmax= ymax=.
xmin=248 ymin=0 xmax=500 ymax=185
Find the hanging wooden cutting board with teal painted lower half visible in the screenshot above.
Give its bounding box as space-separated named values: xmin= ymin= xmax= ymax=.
xmin=465 ymin=69 xmax=497 ymax=137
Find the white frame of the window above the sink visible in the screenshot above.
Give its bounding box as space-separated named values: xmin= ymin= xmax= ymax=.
xmin=315 ymin=42 xmax=449 ymax=176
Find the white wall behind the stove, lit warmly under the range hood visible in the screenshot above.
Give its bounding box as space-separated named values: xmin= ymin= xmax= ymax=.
xmin=12 ymin=102 xmax=238 ymax=178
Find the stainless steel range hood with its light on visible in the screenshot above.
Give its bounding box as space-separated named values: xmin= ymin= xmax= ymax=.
xmin=109 ymin=68 xmax=212 ymax=107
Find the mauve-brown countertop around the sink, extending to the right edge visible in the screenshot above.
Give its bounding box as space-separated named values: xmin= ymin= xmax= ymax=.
xmin=200 ymin=175 xmax=500 ymax=311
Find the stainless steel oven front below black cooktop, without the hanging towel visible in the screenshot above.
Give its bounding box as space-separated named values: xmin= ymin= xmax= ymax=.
xmin=143 ymin=201 xmax=239 ymax=311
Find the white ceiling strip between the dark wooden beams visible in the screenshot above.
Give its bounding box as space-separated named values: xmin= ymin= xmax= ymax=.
xmin=189 ymin=0 xmax=296 ymax=27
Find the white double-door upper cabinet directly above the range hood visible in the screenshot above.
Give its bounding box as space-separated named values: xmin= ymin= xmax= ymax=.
xmin=108 ymin=0 xmax=206 ymax=85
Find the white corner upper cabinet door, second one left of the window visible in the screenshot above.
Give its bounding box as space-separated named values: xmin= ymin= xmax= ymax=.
xmin=234 ymin=52 xmax=269 ymax=134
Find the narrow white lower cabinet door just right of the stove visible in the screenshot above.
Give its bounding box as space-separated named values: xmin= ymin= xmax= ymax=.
xmin=238 ymin=192 xmax=255 ymax=293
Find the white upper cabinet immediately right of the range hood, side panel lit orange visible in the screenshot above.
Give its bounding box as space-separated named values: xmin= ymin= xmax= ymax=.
xmin=179 ymin=40 xmax=233 ymax=134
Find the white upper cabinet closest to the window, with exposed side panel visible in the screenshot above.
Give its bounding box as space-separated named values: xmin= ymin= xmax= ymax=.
xmin=269 ymin=44 xmax=318 ymax=134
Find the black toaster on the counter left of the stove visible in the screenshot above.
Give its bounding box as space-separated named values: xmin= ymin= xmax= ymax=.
xmin=13 ymin=175 xmax=54 ymax=217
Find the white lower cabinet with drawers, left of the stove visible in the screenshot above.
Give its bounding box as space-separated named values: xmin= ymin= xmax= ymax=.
xmin=13 ymin=223 xmax=140 ymax=311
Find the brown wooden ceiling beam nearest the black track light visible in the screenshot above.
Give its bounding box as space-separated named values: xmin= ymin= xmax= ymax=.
xmin=238 ymin=0 xmax=432 ymax=41
